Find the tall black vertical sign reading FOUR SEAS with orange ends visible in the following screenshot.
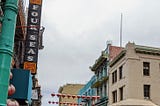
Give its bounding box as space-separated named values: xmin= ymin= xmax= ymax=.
xmin=24 ymin=0 xmax=42 ymax=75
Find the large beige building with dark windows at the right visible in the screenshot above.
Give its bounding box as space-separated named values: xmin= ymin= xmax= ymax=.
xmin=108 ymin=43 xmax=160 ymax=106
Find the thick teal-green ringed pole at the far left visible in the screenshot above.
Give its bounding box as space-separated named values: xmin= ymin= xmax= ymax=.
xmin=0 ymin=0 xmax=18 ymax=106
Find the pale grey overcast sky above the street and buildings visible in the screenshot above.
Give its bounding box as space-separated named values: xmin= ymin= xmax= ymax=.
xmin=31 ymin=0 xmax=160 ymax=106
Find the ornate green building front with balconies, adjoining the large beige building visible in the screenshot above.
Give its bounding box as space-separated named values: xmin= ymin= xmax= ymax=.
xmin=90 ymin=49 xmax=109 ymax=106
